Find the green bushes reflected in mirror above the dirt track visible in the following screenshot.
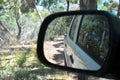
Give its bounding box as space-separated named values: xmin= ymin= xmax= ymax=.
xmin=45 ymin=16 xmax=72 ymax=40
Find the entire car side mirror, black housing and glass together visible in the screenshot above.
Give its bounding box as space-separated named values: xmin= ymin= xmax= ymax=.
xmin=37 ymin=11 xmax=120 ymax=76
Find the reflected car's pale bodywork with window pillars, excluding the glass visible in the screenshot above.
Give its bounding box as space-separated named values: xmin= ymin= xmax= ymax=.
xmin=65 ymin=15 xmax=101 ymax=70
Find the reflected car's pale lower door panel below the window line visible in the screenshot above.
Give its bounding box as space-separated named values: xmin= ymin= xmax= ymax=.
xmin=65 ymin=27 xmax=100 ymax=70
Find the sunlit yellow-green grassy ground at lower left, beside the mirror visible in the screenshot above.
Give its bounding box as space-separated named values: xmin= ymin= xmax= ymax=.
xmin=0 ymin=43 xmax=67 ymax=80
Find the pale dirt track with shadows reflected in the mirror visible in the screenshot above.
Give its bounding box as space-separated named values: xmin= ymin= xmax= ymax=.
xmin=44 ymin=37 xmax=65 ymax=66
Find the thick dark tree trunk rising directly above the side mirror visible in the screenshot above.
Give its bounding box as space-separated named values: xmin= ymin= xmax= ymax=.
xmin=80 ymin=0 xmax=97 ymax=10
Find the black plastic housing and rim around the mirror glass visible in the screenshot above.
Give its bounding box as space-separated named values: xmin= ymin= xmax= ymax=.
xmin=37 ymin=10 xmax=120 ymax=76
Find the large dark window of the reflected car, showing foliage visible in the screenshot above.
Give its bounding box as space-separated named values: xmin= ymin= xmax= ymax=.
xmin=78 ymin=15 xmax=109 ymax=61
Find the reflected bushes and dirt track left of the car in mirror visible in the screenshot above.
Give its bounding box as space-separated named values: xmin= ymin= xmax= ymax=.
xmin=44 ymin=16 xmax=73 ymax=66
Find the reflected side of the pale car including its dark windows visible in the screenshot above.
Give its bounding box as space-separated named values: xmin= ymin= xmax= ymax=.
xmin=65 ymin=15 xmax=109 ymax=70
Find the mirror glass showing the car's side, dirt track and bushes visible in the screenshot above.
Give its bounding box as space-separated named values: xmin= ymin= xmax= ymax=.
xmin=44 ymin=14 xmax=110 ymax=71
